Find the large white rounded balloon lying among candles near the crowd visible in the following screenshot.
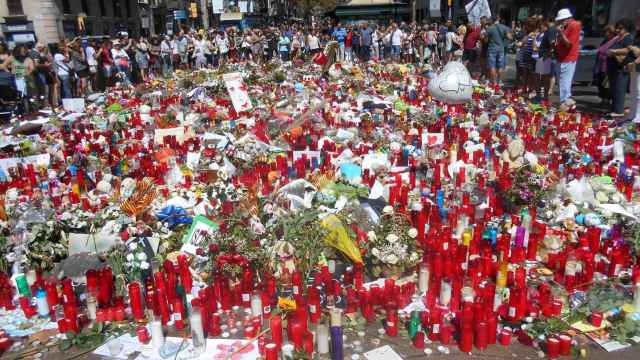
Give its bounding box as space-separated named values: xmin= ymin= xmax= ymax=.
xmin=429 ymin=61 xmax=473 ymax=104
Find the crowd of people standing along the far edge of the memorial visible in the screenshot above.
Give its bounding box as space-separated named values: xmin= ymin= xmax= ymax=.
xmin=0 ymin=9 xmax=640 ymax=122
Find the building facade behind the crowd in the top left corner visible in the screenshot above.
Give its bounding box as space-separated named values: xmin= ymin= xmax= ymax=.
xmin=0 ymin=0 xmax=146 ymax=44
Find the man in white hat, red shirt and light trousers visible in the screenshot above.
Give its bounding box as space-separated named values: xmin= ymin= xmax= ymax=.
xmin=556 ymin=9 xmax=582 ymax=110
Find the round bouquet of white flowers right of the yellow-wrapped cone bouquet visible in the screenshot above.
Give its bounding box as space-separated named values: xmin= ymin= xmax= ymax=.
xmin=364 ymin=206 xmax=422 ymax=277
